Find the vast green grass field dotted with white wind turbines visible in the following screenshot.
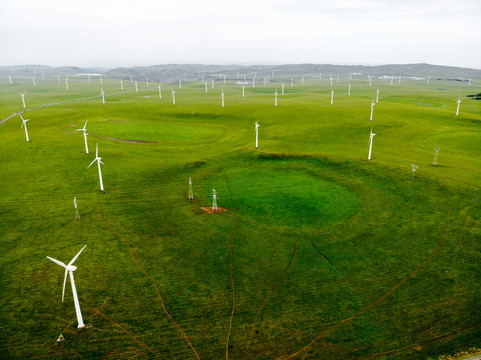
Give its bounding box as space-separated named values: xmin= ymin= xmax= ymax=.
xmin=0 ymin=74 xmax=481 ymax=359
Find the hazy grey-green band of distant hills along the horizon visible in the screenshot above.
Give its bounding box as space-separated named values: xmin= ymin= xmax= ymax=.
xmin=0 ymin=63 xmax=481 ymax=83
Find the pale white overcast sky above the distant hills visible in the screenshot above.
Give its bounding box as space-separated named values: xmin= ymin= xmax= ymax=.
xmin=0 ymin=0 xmax=481 ymax=69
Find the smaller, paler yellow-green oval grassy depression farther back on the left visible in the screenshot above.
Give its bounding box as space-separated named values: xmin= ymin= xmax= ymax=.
xmin=88 ymin=120 xmax=224 ymax=143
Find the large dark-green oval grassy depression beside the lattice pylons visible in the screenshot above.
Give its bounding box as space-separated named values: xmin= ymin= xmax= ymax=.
xmin=204 ymin=167 xmax=360 ymax=227
